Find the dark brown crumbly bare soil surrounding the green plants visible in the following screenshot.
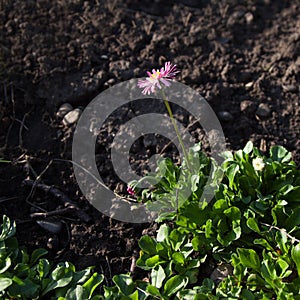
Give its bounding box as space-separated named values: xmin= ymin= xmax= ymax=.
xmin=0 ymin=0 xmax=300 ymax=283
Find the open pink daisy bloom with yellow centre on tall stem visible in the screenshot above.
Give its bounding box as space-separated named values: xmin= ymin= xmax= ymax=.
xmin=138 ymin=61 xmax=179 ymax=95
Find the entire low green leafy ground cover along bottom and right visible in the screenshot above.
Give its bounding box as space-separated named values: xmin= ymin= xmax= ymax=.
xmin=0 ymin=142 xmax=300 ymax=299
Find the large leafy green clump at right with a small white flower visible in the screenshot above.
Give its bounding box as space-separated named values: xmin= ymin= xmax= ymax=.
xmin=134 ymin=142 xmax=300 ymax=299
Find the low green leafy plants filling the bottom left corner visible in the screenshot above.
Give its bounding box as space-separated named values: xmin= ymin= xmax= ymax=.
xmin=0 ymin=216 xmax=103 ymax=300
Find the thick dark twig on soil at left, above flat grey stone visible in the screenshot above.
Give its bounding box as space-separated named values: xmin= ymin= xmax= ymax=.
xmin=23 ymin=179 xmax=91 ymax=222
